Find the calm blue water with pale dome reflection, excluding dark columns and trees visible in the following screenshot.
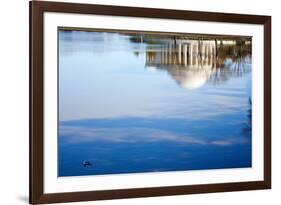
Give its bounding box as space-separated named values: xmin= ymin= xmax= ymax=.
xmin=58 ymin=31 xmax=252 ymax=176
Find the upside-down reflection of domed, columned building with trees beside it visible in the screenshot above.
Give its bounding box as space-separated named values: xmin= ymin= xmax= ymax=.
xmin=142 ymin=36 xmax=251 ymax=90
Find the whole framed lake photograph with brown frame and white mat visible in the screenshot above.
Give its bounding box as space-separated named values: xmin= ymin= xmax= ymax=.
xmin=30 ymin=1 xmax=271 ymax=204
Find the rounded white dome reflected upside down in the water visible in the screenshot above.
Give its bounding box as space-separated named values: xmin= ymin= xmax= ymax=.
xmin=168 ymin=68 xmax=212 ymax=90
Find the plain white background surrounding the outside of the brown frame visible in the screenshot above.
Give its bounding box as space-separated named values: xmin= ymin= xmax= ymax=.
xmin=0 ymin=0 xmax=276 ymax=205
